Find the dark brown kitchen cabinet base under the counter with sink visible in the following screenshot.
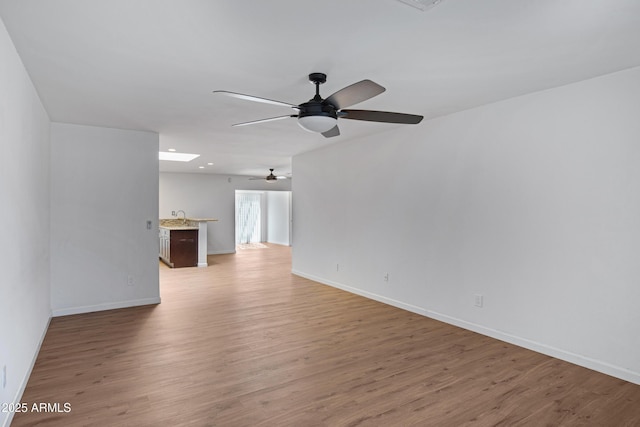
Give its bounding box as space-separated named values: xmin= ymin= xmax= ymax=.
xmin=159 ymin=228 xmax=198 ymax=268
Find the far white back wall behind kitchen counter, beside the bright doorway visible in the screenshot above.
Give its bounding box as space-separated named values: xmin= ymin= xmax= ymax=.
xmin=159 ymin=172 xmax=291 ymax=254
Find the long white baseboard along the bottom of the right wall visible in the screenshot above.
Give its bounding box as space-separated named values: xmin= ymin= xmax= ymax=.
xmin=292 ymin=270 xmax=640 ymax=385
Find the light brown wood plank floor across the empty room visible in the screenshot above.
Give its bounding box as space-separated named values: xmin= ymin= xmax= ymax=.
xmin=12 ymin=245 xmax=640 ymax=426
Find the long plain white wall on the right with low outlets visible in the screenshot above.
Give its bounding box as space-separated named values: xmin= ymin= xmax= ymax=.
xmin=293 ymin=68 xmax=640 ymax=384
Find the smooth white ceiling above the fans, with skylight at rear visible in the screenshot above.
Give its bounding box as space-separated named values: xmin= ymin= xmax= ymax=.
xmin=0 ymin=0 xmax=640 ymax=175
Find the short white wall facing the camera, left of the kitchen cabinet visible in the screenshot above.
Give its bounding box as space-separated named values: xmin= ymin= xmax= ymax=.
xmin=51 ymin=123 xmax=160 ymax=315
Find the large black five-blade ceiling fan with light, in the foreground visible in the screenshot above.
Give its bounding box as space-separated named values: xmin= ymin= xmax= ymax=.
xmin=213 ymin=73 xmax=422 ymax=138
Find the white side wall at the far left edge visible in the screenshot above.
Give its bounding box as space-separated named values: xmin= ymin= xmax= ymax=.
xmin=0 ymin=16 xmax=51 ymax=425
